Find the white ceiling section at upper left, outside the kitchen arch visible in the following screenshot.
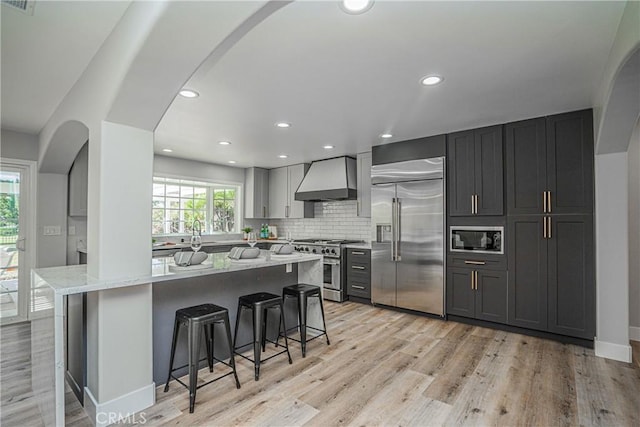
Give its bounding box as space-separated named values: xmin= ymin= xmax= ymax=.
xmin=0 ymin=1 xmax=130 ymax=134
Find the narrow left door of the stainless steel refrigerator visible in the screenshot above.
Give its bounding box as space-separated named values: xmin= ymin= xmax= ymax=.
xmin=371 ymin=184 xmax=396 ymax=306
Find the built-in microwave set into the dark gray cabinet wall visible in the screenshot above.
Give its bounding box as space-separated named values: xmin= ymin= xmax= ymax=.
xmin=449 ymin=225 xmax=504 ymax=255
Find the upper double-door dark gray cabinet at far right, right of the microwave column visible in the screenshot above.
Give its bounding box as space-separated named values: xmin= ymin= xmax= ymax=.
xmin=505 ymin=110 xmax=593 ymax=215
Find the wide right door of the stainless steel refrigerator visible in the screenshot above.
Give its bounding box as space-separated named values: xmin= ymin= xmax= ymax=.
xmin=396 ymin=179 xmax=444 ymax=316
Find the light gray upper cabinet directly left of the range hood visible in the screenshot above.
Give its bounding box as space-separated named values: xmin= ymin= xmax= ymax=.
xmin=268 ymin=163 xmax=313 ymax=218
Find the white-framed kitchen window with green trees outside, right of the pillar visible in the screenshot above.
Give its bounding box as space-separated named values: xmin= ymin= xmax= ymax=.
xmin=152 ymin=177 xmax=240 ymax=234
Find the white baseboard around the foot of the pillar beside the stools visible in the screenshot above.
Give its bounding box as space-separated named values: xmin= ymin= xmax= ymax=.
xmin=84 ymin=383 xmax=156 ymax=427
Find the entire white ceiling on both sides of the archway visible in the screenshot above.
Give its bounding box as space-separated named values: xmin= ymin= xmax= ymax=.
xmin=2 ymin=0 xmax=624 ymax=171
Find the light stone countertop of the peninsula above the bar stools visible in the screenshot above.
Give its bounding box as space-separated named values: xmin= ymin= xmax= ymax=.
xmin=32 ymin=250 xmax=322 ymax=295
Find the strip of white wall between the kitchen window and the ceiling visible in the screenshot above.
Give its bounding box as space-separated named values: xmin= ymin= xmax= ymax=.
xmin=153 ymin=154 xmax=244 ymax=185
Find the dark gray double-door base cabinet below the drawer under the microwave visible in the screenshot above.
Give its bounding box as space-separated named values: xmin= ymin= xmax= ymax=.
xmin=447 ymin=267 xmax=507 ymax=323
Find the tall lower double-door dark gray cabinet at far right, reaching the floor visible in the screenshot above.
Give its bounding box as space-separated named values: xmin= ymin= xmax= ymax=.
xmin=507 ymin=215 xmax=595 ymax=340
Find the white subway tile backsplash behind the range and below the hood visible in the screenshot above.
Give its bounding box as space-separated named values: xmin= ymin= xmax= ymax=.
xmin=245 ymin=200 xmax=371 ymax=241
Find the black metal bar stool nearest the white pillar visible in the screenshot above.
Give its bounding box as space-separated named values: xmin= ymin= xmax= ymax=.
xmin=164 ymin=304 xmax=240 ymax=413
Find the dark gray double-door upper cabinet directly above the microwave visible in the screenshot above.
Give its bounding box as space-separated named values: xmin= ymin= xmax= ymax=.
xmin=447 ymin=126 xmax=504 ymax=216
